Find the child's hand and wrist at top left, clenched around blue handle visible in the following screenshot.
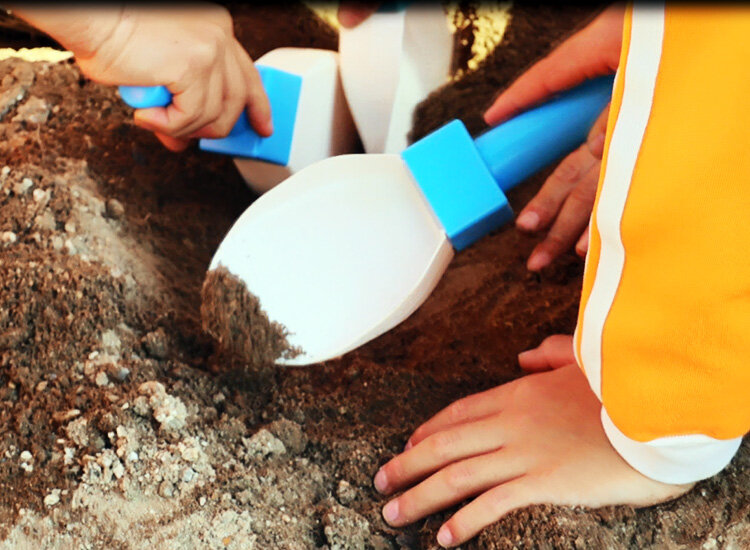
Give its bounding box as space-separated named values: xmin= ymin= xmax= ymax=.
xmin=16 ymin=3 xmax=272 ymax=151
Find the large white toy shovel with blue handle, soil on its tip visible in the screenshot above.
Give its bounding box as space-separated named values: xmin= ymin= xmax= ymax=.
xmin=209 ymin=77 xmax=612 ymax=365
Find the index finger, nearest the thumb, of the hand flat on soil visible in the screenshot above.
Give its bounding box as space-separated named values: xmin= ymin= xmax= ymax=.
xmin=406 ymin=385 xmax=508 ymax=450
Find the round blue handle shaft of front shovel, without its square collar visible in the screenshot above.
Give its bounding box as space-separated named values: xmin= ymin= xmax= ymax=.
xmin=474 ymin=76 xmax=614 ymax=191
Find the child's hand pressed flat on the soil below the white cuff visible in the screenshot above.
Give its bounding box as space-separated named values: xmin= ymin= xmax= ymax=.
xmin=375 ymin=337 xmax=691 ymax=547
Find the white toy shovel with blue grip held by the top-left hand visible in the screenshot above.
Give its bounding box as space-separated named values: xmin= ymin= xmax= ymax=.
xmin=120 ymin=48 xmax=358 ymax=193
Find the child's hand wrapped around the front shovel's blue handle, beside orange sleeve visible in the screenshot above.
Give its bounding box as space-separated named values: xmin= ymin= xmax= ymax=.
xmin=484 ymin=4 xmax=624 ymax=271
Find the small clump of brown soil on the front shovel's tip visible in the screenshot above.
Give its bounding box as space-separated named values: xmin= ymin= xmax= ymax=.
xmin=206 ymin=266 xmax=301 ymax=368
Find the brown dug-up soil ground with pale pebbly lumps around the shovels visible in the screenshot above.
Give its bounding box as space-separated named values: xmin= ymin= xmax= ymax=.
xmin=0 ymin=4 xmax=750 ymax=550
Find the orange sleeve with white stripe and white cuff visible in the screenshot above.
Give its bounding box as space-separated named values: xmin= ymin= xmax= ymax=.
xmin=575 ymin=4 xmax=750 ymax=483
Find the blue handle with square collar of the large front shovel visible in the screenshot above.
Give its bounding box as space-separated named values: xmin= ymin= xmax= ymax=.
xmin=401 ymin=77 xmax=613 ymax=250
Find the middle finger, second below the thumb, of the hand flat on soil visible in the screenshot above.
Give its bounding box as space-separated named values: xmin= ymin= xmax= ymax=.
xmin=374 ymin=415 xmax=505 ymax=494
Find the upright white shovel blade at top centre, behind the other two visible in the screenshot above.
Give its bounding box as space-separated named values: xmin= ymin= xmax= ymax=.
xmin=339 ymin=2 xmax=453 ymax=153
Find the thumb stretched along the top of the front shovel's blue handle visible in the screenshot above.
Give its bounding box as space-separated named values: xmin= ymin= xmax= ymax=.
xmin=484 ymin=4 xmax=624 ymax=126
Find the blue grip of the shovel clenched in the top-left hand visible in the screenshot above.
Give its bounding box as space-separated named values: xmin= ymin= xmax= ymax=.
xmin=115 ymin=65 xmax=302 ymax=166
